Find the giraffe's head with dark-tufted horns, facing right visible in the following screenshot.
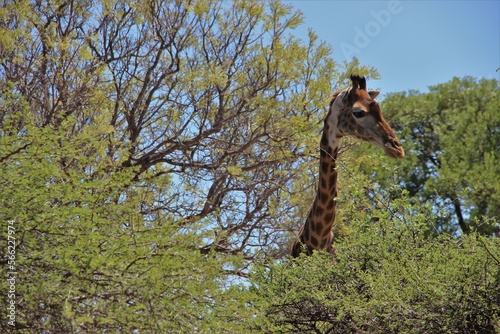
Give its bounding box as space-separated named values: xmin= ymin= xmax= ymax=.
xmin=325 ymin=75 xmax=405 ymax=159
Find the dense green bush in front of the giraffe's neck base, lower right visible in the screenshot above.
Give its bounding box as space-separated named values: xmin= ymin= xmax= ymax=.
xmin=253 ymin=192 xmax=500 ymax=333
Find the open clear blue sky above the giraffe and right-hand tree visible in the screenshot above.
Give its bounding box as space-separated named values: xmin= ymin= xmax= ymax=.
xmin=284 ymin=0 xmax=500 ymax=93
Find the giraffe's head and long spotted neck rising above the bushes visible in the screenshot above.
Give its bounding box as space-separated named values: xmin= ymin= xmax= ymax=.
xmin=291 ymin=75 xmax=404 ymax=257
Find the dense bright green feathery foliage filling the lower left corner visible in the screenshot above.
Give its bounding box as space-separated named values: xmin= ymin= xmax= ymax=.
xmin=0 ymin=107 xmax=258 ymax=332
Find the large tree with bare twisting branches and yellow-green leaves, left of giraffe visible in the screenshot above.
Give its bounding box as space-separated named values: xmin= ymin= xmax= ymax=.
xmin=0 ymin=1 xmax=376 ymax=332
